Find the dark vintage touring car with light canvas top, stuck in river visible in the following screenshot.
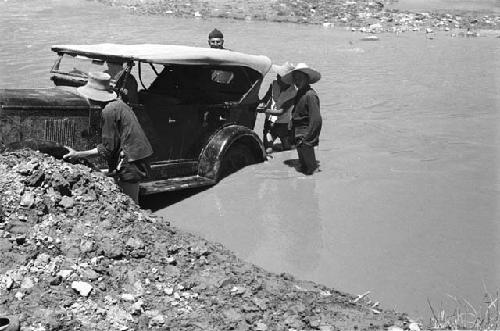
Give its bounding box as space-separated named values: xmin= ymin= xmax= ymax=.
xmin=0 ymin=44 xmax=271 ymax=195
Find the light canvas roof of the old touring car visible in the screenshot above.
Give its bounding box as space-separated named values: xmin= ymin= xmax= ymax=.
xmin=52 ymin=44 xmax=271 ymax=76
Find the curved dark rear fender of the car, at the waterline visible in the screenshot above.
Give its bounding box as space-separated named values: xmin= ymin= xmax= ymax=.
xmin=198 ymin=125 xmax=266 ymax=181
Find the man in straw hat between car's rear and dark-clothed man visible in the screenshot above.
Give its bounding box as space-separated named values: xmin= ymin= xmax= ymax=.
xmin=259 ymin=62 xmax=297 ymax=153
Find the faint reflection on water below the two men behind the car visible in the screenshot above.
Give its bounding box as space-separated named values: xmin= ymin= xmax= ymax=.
xmin=254 ymin=174 xmax=322 ymax=274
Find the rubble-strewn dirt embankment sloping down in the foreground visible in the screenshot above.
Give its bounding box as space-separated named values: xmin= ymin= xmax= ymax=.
xmin=0 ymin=150 xmax=406 ymax=331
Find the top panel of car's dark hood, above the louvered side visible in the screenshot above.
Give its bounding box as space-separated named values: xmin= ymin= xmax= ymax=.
xmin=0 ymin=88 xmax=90 ymax=110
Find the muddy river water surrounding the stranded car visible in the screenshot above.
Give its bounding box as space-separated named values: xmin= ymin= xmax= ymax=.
xmin=0 ymin=0 xmax=500 ymax=317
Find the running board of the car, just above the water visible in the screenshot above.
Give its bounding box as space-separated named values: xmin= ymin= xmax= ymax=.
xmin=139 ymin=176 xmax=216 ymax=195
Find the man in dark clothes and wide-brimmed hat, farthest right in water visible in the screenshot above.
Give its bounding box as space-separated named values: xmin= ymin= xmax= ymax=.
xmin=282 ymin=63 xmax=322 ymax=175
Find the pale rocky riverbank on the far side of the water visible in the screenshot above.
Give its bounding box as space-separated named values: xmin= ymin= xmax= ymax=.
xmin=89 ymin=0 xmax=500 ymax=32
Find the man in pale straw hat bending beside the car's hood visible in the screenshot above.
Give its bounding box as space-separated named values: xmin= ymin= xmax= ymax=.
xmin=64 ymin=72 xmax=153 ymax=203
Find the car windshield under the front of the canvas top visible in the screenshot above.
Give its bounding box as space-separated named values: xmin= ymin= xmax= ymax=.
xmin=52 ymin=54 xmax=123 ymax=80
